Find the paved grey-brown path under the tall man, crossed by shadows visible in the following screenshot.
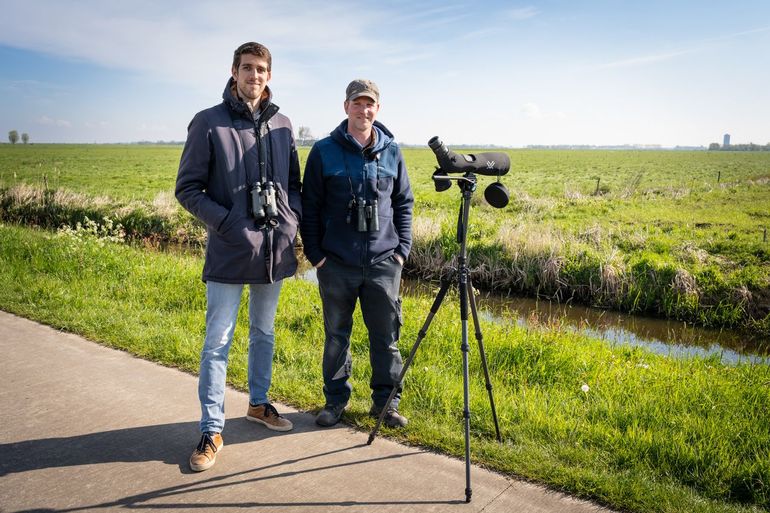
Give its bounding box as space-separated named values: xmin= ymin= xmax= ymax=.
xmin=0 ymin=312 xmax=607 ymax=513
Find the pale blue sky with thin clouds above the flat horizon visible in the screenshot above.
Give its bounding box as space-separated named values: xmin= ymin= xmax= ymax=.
xmin=0 ymin=0 xmax=770 ymax=147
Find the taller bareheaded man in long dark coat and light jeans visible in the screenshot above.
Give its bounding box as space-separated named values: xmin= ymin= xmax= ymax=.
xmin=176 ymin=43 xmax=302 ymax=471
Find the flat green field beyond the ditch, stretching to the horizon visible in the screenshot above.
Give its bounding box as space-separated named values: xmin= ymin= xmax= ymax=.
xmin=0 ymin=145 xmax=770 ymax=337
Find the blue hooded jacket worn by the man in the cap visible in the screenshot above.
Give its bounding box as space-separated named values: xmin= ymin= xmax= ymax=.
xmin=301 ymin=119 xmax=414 ymax=266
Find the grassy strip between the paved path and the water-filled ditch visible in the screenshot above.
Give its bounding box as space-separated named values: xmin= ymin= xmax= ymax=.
xmin=0 ymin=221 xmax=770 ymax=512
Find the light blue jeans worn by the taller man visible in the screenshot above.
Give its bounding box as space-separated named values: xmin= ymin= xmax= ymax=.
xmin=198 ymin=281 xmax=283 ymax=433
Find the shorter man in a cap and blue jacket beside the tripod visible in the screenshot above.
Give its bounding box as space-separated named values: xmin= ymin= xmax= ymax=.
xmin=301 ymin=79 xmax=414 ymax=427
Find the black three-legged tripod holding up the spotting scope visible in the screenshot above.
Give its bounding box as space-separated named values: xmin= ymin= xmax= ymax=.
xmin=366 ymin=172 xmax=502 ymax=502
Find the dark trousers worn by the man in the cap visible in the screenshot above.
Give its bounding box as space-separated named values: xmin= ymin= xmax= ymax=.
xmin=317 ymin=256 xmax=403 ymax=407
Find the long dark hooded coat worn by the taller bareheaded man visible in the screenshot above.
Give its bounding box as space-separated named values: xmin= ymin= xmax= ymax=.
xmin=176 ymin=78 xmax=302 ymax=283
